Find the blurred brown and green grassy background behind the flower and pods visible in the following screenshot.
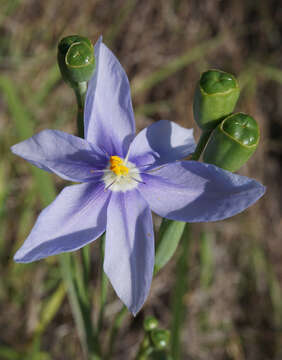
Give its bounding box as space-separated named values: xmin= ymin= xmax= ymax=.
xmin=0 ymin=0 xmax=282 ymax=360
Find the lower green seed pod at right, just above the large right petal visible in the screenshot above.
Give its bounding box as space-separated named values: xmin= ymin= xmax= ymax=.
xmin=203 ymin=113 xmax=260 ymax=172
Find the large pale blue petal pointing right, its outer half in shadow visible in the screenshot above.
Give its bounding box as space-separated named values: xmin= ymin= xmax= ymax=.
xmin=139 ymin=161 xmax=265 ymax=222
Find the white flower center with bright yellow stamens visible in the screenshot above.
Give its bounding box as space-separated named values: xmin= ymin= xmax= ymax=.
xmin=102 ymin=155 xmax=142 ymax=192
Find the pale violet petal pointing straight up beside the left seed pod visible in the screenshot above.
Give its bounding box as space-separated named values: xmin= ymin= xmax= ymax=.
xmin=84 ymin=38 xmax=135 ymax=157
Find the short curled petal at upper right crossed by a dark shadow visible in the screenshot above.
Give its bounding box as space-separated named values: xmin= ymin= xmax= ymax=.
xmin=129 ymin=120 xmax=196 ymax=165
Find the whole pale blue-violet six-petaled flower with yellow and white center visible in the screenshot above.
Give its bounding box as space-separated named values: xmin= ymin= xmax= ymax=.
xmin=11 ymin=39 xmax=265 ymax=314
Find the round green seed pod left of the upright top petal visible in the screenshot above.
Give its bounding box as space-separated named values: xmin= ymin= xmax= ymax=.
xmin=58 ymin=35 xmax=95 ymax=85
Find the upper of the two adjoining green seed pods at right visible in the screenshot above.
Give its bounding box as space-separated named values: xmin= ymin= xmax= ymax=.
xmin=193 ymin=70 xmax=240 ymax=130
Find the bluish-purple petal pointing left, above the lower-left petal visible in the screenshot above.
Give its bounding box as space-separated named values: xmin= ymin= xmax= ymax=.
xmin=11 ymin=130 xmax=106 ymax=182
